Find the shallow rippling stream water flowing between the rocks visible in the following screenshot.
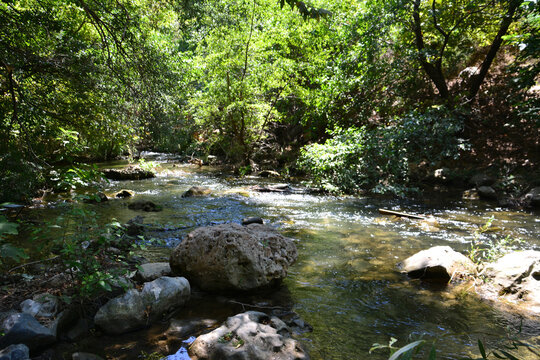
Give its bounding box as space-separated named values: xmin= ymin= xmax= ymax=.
xmin=19 ymin=157 xmax=540 ymax=359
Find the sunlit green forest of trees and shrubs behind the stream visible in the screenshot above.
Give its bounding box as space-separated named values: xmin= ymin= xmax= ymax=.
xmin=0 ymin=0 xmax=540 ymax=201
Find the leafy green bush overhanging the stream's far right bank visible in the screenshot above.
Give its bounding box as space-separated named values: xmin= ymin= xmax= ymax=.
xmin=298 ymin=108 xmax=467 ymax=195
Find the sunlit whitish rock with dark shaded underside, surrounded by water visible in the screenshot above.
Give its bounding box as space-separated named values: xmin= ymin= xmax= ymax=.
xmin=398 ymin=246 xmax=476 ymax=283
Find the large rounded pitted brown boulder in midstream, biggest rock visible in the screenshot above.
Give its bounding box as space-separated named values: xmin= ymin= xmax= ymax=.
xmin=170 ymin=224 xmax=297 ymax=291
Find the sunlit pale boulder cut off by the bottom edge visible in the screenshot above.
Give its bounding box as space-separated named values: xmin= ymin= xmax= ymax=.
xmin=190 ymin=311 xmax=309 ymax=360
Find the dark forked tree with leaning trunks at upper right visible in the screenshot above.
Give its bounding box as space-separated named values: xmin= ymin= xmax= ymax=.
xmin=411 ymin=0 xmax=523 ymax=99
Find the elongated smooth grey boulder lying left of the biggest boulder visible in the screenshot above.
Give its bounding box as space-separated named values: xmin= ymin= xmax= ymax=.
xmin=94 ymin=276 xmax=191 ymax=334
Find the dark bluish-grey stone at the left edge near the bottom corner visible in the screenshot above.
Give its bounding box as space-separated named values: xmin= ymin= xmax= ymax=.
xmin=0 ymin=313 xmax=56 ymax=350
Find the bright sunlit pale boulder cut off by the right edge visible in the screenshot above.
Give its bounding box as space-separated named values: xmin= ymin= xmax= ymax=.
xmin=481 ymin=250 xmax=540 ymax=313
